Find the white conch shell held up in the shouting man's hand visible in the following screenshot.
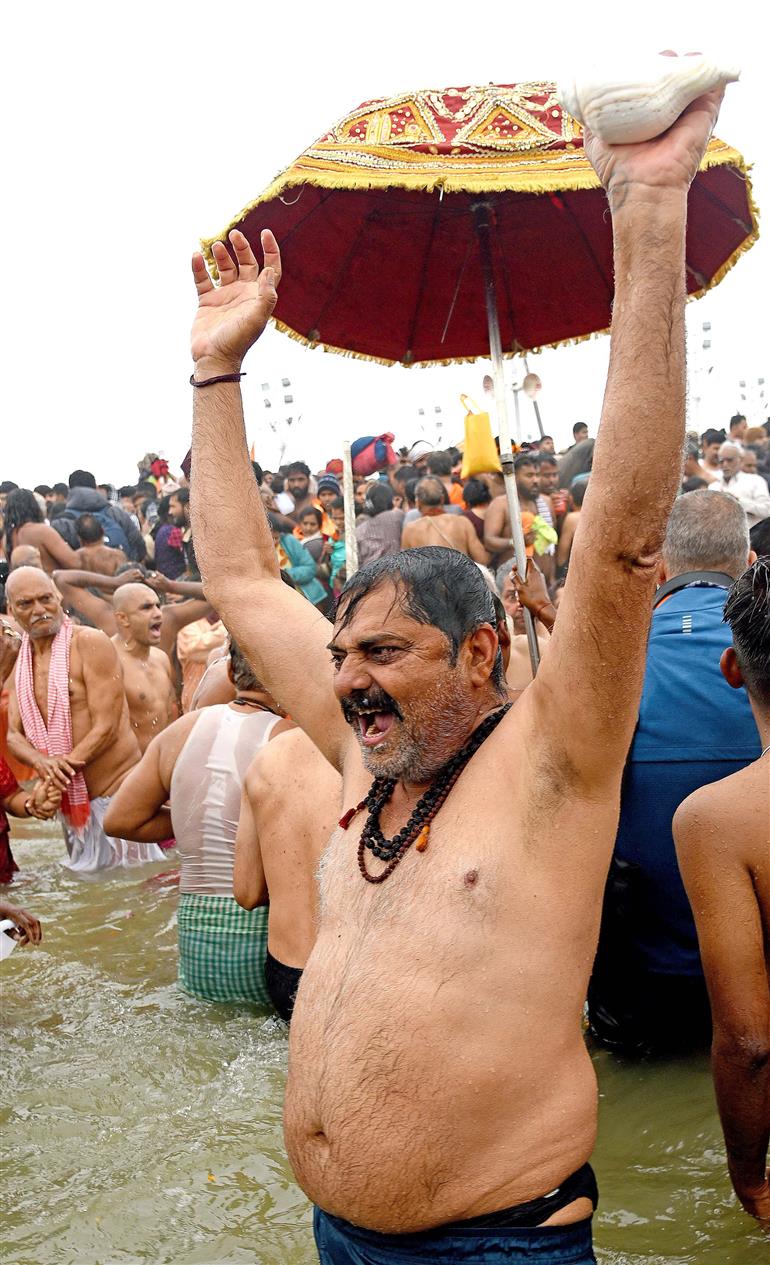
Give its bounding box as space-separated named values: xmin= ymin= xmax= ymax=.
xmin=556 ymin=53 xmax=741 ymax=145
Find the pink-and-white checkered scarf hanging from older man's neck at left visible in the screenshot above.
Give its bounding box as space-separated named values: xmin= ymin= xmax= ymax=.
xmin=16 ymin=617 xmax=91 ymax=830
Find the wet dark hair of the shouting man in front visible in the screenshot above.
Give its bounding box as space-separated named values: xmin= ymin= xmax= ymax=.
xmin=336 ymin=545 xmax=506 ymax=696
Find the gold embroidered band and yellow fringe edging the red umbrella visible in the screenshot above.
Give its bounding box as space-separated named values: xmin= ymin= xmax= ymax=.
xmin=201 ymin=138 xmax=760 ymax=368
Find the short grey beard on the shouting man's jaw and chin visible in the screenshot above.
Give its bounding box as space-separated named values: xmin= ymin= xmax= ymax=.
xmin=362 ymin=673 xmax=475 ymax=786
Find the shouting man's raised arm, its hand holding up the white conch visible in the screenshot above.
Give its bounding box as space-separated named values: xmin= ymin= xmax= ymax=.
xmin=526 ymin=92 xmax=721 ymax=786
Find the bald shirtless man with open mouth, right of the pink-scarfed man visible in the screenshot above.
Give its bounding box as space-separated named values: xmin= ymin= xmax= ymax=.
xmin=113 ymin=584 xmax=178 ymax=755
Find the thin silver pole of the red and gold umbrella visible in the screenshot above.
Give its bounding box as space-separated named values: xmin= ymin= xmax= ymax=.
xmin=473 ymin=202 xmax=540 ymax=676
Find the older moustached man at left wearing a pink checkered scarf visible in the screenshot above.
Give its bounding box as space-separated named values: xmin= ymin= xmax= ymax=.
xmin=6 ymin=567 xmax=163 ymax=873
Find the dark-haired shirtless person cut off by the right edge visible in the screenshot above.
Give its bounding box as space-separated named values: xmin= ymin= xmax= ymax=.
xmin=674 ymin=558 xmax=770 ymax=1230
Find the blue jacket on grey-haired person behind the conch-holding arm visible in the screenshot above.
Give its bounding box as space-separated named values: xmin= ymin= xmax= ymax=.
xmin=607 ymin=584 xmax=760 ymax=975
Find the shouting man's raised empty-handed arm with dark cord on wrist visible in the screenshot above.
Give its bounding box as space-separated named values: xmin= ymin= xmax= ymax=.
xmin=190 ymin=230 xmax=350 ymax=768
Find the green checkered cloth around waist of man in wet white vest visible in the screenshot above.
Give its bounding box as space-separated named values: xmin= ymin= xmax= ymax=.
xmin=177 ymin=892 xmax=272 ymax=1008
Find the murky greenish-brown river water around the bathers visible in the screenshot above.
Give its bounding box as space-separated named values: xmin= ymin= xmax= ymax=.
xmin=0 ymin=825 xmax=770 ymax=1265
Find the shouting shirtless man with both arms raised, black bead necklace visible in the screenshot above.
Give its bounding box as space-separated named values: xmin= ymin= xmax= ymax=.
xmin=191 ymin=95 xmax=718 ymax=1265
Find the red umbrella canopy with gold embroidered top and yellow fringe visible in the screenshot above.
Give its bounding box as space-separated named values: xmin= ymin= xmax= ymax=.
xmin=204 ymin=83 xmax=759 ymax=364
